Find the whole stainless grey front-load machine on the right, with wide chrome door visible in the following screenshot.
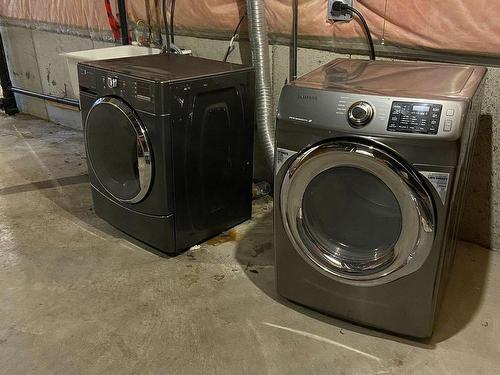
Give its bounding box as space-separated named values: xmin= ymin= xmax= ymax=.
xmin=274 ymin=59 xmax=486 ymax=337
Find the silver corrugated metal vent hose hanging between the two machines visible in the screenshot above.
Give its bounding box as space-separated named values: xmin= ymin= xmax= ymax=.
xmin=247 ymin=0 xmax=275 ymax=170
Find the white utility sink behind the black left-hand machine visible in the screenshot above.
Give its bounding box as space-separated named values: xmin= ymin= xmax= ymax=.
xmin=61 ymin=45 xmax=160 ymax=98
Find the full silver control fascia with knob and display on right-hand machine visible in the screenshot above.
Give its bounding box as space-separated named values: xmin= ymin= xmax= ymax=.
xmin=277 ymin=84 xmax=470 ymax=140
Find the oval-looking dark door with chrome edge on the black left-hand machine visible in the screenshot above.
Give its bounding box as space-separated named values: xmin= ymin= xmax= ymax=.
xmin=85 ymin=97 xmax=153 ymax=203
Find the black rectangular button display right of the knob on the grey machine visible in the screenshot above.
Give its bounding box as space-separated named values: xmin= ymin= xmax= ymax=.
xmin=387 ymin=101 xmax=443 ymax=134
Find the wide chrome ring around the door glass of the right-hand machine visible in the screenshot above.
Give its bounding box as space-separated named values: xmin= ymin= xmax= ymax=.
xmin=279 ymin=139 xmax=435 ymax=286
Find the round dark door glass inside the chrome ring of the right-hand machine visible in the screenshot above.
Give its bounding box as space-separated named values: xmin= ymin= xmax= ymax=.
xmin=302 ymin=166 xmax=402 ymax=271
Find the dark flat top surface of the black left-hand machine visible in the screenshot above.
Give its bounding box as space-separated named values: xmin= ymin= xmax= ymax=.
xmin=82 ymin=54 xmax=252 ymax=82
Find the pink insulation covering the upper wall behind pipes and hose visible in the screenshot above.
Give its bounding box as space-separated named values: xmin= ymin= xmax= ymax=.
xmin=0 ymin=0 xmax=500 ymax=55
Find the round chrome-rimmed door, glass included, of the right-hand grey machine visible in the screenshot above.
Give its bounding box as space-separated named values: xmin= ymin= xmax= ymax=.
xmin=280 ymin=140 xmax=434 ymax=286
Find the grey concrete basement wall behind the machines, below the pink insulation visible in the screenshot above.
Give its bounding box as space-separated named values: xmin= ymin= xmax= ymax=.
xmin=0 ymin=26 xmax=500 ymax=249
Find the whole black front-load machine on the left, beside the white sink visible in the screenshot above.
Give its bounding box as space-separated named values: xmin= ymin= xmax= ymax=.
xmin=78 ymin=54 xmax=254 ymax=253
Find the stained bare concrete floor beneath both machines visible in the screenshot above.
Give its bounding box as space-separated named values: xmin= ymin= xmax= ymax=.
xmin=0 ymin=115 xmax=500 ymax=375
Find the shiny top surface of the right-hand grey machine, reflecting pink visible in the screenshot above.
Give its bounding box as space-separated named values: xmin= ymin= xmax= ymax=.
xmin=292 ymin=59 xmax=486 ymax=99
